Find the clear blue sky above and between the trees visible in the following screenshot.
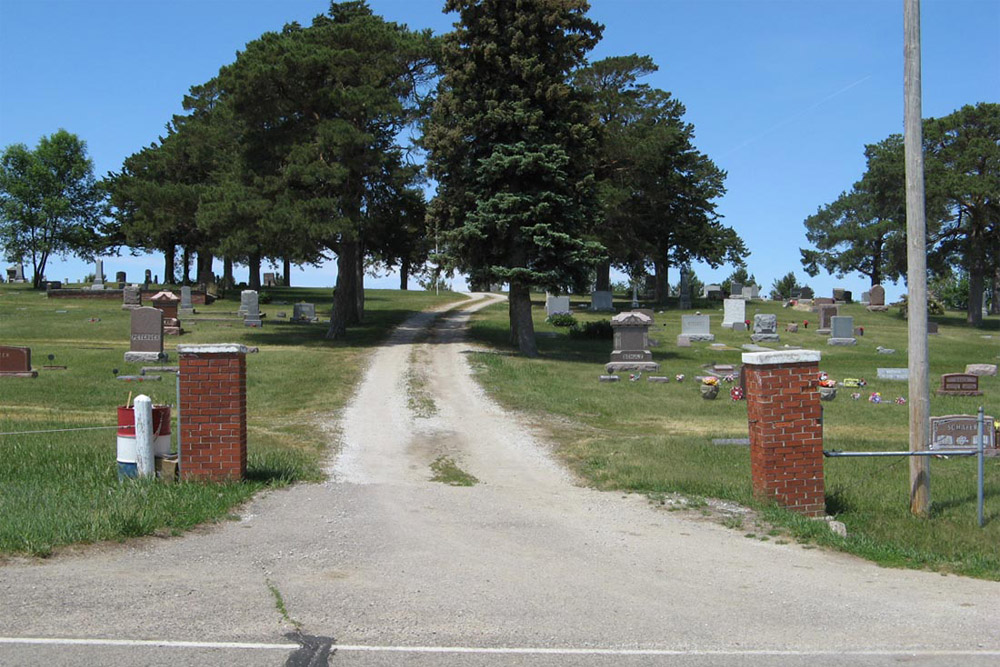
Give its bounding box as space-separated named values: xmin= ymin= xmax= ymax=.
xmin=0 ymin=0 xmax=1000 ymax=298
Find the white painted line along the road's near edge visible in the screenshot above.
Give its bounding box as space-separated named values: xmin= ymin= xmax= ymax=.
xmin=0 ymin=637 xmax=1000 ymax=657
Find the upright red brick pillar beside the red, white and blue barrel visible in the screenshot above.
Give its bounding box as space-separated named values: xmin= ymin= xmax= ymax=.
xmin=177 ymin=344 xmax=247 ymax=482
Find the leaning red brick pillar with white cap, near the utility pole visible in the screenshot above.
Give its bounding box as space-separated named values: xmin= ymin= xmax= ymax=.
xmin=743 ymin=350 xmax=826 ymax=516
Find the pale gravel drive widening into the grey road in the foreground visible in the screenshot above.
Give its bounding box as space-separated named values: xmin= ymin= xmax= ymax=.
xmin=0 ymin=297 xmax=1000 ymax=667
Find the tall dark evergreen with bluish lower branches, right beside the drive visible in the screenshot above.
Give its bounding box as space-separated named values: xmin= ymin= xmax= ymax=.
xmin=424 ymin=0 xmax=602 ymax=356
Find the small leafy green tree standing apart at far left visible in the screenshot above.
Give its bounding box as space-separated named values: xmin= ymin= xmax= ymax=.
xmin=0 ymin=129 xmax=105 ymax=288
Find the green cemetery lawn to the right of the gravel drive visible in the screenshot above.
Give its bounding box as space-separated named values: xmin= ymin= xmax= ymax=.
xmin=472 ymin=297 xmax=1000 ymax=579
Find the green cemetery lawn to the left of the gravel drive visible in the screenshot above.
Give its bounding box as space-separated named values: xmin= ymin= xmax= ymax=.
xmin=0 ymin=284 xmax=461 ymax=556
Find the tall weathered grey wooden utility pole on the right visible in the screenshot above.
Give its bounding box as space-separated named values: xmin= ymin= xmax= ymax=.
xmin=903 ymin=0 xmax=931 ymax=517
